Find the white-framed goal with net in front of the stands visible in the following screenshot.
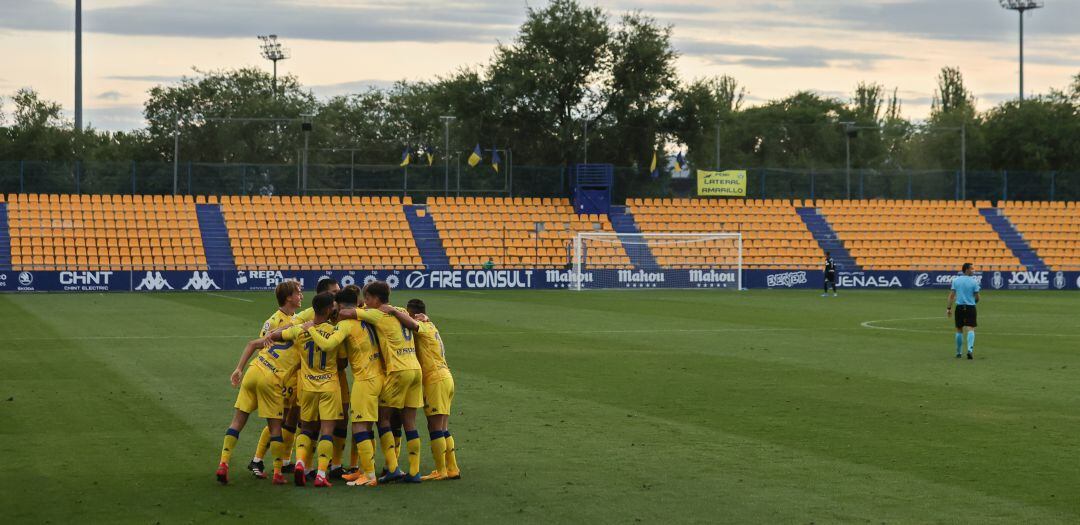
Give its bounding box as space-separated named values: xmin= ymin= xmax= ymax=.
xmin=568 ymin=232 xmax=743 ymax=291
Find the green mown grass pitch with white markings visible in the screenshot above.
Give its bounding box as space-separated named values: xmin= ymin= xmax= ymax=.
xmin=0 ymin=291 xmax=1080 ymax=523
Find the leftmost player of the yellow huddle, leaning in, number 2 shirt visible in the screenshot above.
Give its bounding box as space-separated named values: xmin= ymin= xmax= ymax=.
xmin=217 ymin=285 xmax=300 ymax=485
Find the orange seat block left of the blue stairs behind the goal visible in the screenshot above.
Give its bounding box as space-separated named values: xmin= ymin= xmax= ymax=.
xmin=428 ymin=197 xmax=633 ymax=269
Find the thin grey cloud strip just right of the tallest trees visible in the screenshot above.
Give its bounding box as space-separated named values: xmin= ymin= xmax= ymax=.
xmin=676 ymin=40 xmax=897 ymax=68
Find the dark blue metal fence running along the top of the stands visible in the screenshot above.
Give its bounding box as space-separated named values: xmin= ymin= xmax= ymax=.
xmin=0 ymin=161 xmax=1080 ymax=202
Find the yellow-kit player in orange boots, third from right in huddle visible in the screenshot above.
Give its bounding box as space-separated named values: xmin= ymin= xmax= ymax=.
xmin=311 ymin=286 xmax=386 ymax=486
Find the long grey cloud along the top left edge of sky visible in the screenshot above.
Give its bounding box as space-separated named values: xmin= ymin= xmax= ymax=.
xmin=0 ymin=0 xmax=525 ymax=42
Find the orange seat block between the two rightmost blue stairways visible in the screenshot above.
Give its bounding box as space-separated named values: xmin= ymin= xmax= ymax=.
xmin=816 ymin=200 xmax=1024 ymax=271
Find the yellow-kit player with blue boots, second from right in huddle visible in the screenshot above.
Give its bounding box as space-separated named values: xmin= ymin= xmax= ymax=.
xmin=338 ymin=281 xmax=423 ymax=483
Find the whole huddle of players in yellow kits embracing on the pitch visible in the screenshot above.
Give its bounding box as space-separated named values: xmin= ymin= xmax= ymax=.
xmin=216 ymin=279 xmax=461 ymax=487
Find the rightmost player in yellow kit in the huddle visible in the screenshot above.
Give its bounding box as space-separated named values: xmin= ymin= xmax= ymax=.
xmin=406 ymin=299 xmax=461 ymax=481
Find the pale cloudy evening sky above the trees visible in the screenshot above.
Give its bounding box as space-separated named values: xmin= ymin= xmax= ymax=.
xmin=0 ymin=0 xmax=1080 ymax=131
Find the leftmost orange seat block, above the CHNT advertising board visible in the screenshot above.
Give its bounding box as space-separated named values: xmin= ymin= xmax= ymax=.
xmin=8 ymin=193 xmax=206 ymax=271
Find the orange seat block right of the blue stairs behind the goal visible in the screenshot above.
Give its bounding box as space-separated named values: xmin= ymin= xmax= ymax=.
xmin=626 ymin=199 xmax=824 ymax=269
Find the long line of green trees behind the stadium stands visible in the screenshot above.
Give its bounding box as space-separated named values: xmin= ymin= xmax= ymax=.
xmin=0 ymin=0 xmax=1080 ymax=177
